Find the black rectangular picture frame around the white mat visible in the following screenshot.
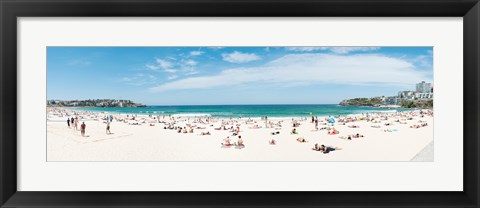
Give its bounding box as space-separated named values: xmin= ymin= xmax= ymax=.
xmin=0 ymin=0 xmax=480 ymax=207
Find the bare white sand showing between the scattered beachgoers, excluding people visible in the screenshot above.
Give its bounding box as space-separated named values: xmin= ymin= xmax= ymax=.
xmin=47 ymin=108 xmax=433 ymax=161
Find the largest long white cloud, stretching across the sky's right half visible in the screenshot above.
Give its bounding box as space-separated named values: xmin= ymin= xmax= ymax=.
xmin=150 ymin=53 xmax=430 ymax=92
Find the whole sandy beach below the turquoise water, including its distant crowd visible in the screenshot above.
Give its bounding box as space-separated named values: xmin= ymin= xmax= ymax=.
xmin=47 ymin=108 xmax=433 ymax=162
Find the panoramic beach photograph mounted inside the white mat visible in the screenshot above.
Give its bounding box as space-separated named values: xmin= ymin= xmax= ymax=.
xmin=46 ymin=46 xmax=434 ymax=162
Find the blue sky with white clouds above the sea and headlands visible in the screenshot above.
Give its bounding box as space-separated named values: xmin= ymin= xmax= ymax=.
xmin=47 ymin=47 xmax=433 ymax=105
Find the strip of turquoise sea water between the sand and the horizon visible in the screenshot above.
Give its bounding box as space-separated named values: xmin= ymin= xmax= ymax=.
xmin=79 ymin=105 xmax=412 ymax=118
